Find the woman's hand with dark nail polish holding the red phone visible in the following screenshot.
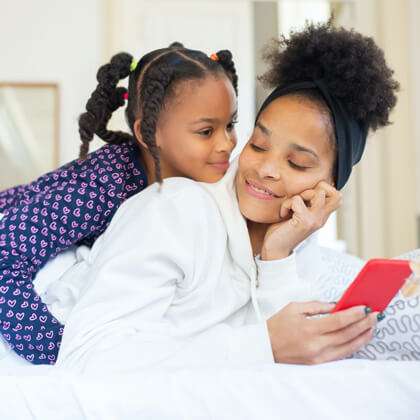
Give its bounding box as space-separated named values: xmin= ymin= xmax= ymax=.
xmin=267 ymin=302 xmax=378 ymax=365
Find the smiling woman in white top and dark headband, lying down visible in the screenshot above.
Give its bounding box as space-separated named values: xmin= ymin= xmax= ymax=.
xmin=58 ymin=24 xmax=397 ymax=372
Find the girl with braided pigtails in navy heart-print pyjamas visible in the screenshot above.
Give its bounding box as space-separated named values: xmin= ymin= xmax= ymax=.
xmin=0 ymin=43 xmax=237 ymax=364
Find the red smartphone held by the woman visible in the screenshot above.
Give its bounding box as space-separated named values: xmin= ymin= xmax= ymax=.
xmin=332 ymin=259 xmax=411 ymax=312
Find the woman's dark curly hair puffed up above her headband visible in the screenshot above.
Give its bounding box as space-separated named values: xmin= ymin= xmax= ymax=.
xmin=259 ymin=20 xmax=399 ymax=131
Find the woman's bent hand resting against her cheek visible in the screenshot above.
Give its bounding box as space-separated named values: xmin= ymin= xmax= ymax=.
xmin=261 ymin=181 xmax=341 ymax=260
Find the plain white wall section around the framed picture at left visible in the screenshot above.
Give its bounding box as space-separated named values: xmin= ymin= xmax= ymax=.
xmin=0 ymin=0 xmax=104 ymax=162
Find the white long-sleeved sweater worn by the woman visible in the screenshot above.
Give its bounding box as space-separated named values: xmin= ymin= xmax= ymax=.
xmin=57 ymin=162 xmax=313 ymax=372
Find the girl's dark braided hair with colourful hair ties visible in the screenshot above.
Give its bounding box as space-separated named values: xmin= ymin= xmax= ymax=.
xmin=79 ymin=42 xmax=238 ymax=182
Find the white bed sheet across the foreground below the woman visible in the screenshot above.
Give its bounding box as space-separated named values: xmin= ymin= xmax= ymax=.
xmin=0 ymin=360 xmax=420 ymax=420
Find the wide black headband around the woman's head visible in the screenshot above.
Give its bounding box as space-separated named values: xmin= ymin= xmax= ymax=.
xmin=255 ymin=80 xmax=368 ymax=190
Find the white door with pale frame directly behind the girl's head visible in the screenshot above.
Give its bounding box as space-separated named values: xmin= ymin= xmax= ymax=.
xmin=107 ymin=0 xmax=255 ymax=151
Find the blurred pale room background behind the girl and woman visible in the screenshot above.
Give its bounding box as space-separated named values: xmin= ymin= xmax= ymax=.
xmin=0 ymin=0 xmax=420 ymax=258
